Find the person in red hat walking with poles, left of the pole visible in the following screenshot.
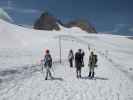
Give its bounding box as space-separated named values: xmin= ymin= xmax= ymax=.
xmin=44 ymin=49 xmax=53 ymax=80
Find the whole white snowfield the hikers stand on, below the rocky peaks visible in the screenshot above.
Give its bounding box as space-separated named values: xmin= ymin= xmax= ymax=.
xmin=0 ymin=20 xmax=133 ymax=100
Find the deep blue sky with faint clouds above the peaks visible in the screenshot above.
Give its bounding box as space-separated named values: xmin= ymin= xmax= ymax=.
xmin=0 ymin=0 xmax=133 ymax=35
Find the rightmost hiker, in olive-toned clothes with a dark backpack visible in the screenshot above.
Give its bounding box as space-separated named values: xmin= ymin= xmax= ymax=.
xmin=88 ymin=51 xmax=97 ymax=78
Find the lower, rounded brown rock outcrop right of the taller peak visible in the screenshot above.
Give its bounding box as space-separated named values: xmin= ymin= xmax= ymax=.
xmin=65 ymin=19 xmax=97 ymax=33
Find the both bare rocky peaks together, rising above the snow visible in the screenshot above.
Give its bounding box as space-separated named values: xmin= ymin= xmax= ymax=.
xmin=34 ymin=12 xmax=97 ymax=33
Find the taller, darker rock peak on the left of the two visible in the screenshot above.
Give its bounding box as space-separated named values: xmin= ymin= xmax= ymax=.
xmin=34 ymin=12 xmax=60 ymax=30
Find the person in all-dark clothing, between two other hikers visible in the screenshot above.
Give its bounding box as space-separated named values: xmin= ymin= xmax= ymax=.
xmin=75 ymin=49 xmax=82 ymax=78
